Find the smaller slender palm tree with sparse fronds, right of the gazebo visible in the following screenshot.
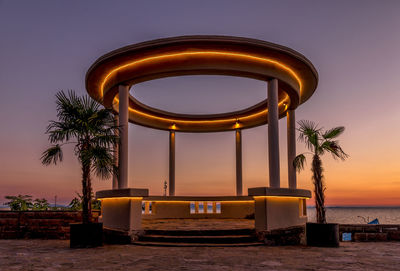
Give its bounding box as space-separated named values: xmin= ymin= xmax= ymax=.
xmin=293 ymin=120 xmax=348 ymax=224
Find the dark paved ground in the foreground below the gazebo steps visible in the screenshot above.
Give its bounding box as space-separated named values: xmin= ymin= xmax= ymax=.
xmin=0 ymin=240 xmax=400 ymax=271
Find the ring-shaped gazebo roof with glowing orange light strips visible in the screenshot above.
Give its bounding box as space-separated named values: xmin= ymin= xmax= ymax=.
xmin=86 ymin=36 xmax=318 ymax=132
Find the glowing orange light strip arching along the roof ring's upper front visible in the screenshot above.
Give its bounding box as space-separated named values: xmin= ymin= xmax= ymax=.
xmin=100 ymin=51 xmax=302 ymax=98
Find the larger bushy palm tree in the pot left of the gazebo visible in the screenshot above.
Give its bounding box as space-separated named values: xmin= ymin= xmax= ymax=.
xmin=41 ymin=91 xmax=118 ymax=223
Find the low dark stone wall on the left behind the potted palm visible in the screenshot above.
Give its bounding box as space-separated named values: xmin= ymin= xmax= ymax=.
xmin=0 ymin=211 xmax=97 ymax=239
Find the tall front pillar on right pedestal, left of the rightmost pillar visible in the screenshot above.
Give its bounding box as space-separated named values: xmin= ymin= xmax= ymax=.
xmin=268 ymin=79 xmax=281 ymax=188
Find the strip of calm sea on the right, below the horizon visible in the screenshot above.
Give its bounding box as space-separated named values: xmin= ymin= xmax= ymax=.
xmin=307 ymin=207 xmax=400 ymax=224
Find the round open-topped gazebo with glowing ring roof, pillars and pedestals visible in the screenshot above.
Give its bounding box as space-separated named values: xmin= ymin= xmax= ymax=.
xmin=86 ymin=36 xmax=318 ymax=238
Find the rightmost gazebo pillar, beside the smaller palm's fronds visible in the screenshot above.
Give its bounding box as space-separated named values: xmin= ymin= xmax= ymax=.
xmin=286 ymin=109 xmax=297 ymax=189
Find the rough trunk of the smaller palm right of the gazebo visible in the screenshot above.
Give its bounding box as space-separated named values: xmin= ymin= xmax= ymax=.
xmin=312 ymin=154 xmax=326 ymax=224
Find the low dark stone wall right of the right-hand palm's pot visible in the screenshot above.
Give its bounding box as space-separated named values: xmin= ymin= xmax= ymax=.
xmin=339 ymin=224 xmax=400 ymax=242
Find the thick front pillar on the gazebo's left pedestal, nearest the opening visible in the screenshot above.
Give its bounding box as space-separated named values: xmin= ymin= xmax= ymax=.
xmin=118 ymin=85 xmax=129 ymax=189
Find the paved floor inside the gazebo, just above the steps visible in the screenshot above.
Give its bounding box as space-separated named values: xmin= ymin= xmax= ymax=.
xmin=142 ymin=218 xmax=254 ymax=230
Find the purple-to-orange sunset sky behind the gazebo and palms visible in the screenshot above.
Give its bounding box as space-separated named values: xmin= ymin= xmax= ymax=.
xmin=0 ymin=0 xmax=400 ymax=206
